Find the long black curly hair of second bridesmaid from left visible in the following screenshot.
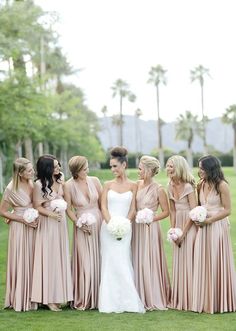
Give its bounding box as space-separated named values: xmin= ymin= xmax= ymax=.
xmin=36 ymin=154 xmax=62 ymax=197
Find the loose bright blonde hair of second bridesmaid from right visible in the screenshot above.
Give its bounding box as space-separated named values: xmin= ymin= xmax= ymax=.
xmin=166 ymin=155 xmax=195 ymax=186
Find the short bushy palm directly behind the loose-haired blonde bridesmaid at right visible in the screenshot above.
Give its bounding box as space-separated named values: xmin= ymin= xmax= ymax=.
xmin=175 ymin=110 xmax=201 ymax=168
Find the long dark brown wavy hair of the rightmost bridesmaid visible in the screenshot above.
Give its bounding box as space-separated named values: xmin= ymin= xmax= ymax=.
xmin=198 ymin=155 xmax=228 ymax=194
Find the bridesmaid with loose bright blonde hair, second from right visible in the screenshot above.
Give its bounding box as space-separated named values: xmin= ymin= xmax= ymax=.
xmin=166 ymin=155 xmax=197 ymax=310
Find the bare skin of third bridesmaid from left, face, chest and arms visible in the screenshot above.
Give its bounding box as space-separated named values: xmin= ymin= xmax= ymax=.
xmin=64 ymin=163 xmax=102 ymax=234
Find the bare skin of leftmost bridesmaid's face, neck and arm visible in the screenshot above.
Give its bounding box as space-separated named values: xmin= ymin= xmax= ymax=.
xmin=0 ymin=163 xmax=38 ymax=228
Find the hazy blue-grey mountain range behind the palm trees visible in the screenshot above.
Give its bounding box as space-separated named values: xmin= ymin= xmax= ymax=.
xmin=98 ymin=115 xmax=233 ymax=154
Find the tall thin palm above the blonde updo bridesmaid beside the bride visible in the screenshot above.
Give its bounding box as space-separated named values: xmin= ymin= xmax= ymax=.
xmin=148 ymin=64 xmax=167 ymax=166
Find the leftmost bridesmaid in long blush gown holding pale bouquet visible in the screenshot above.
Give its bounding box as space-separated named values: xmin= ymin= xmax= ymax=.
xmin=0 ymin=158 xmax=37 ymax=311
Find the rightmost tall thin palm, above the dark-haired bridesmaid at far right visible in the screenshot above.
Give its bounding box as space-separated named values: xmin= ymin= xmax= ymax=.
xmin=190 ymin=64 xmax=210 ymax=154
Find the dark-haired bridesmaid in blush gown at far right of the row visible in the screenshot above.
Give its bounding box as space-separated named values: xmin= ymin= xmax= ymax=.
xmin=192 ymin=155 xmax=236 ymax=314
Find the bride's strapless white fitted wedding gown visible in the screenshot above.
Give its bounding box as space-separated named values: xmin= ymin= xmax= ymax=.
xmin=98 ymin=190 xmax=145 ymax=313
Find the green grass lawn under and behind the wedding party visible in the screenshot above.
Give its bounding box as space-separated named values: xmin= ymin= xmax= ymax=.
xmin=0 ymin=168 xmax=236 ymax=331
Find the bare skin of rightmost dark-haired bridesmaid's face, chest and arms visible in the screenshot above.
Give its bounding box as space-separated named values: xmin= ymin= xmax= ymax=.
xmin=195 ymin=162 xmax=231 ymax=227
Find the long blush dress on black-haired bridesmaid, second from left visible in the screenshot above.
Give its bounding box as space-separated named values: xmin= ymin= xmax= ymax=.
xmin=32 ymin=181 xmax=73 ymax=305
